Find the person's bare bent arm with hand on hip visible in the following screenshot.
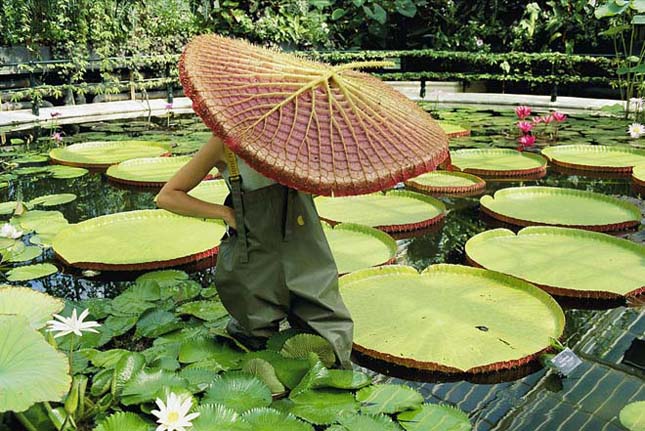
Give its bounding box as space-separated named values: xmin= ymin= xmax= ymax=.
xmin=156 ymin=137 xmax=235 ymax=228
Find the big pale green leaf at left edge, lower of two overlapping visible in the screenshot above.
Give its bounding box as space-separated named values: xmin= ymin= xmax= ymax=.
xmin=0 ymin=315 xmax=71 ymax=412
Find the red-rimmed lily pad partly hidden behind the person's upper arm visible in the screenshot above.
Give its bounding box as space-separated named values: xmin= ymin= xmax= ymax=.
xmin=106 ymin=156 xmax=219 ymax=187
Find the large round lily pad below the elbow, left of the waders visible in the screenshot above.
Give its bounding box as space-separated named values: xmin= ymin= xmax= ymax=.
xmin=53 ymin=210 xmax=224 ymax=270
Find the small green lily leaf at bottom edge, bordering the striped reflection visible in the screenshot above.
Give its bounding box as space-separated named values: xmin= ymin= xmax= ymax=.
xmin=397 ymin=404 xmax=472 ymax=431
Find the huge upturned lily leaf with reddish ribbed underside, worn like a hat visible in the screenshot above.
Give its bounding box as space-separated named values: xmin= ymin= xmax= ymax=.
xmin=179 ymin=35 xmax=448 ymax=196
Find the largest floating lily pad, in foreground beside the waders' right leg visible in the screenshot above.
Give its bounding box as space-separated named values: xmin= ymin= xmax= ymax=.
xmin=340 ymin=265 xmax=564 ymax=373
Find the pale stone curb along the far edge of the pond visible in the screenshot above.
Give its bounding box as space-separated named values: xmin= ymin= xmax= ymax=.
xmin=0 ymin=82 xmax=621 ymax=130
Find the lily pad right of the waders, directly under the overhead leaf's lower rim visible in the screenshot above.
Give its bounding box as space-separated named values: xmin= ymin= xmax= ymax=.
xmin=316 ymin=190 xmax=446 ymax=232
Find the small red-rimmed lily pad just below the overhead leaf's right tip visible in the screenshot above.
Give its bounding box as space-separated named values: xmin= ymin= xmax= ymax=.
xmin=405 ymin=171 xmax=486 ymax=193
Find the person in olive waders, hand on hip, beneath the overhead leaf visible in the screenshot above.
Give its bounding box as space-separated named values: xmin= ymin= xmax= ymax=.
xmin=156 ymin=136 xmax=353 ymax=368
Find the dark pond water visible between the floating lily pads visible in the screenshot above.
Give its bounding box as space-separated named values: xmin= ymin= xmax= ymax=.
xmin=0 ymin=108 xmax=645 ymax=431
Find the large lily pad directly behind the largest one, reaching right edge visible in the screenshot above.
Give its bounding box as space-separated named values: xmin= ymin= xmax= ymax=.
xmin=466 ymin=226 xmax=645 ymax=297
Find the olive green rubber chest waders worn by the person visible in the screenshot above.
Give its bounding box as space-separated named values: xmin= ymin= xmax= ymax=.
xmin=215 ymin=150 xmax=354 ymax=368
